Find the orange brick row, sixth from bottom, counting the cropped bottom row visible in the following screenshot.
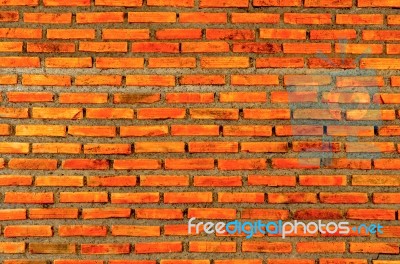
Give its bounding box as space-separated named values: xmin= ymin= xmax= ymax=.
xmin=0 ymin=174 xmax=400 ymax=187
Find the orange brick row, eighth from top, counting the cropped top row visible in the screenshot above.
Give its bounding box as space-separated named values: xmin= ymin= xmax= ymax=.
xmin=0 ymin=107 xmax=400 ymax=120
